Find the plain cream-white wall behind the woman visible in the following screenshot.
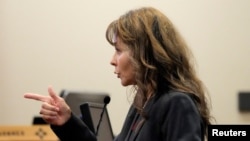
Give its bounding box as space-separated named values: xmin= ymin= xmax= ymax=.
xmin=0 ymin=0 xmax=250 ymax=133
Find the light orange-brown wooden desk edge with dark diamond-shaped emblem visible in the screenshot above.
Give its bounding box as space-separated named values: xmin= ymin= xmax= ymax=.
xmin=0 ymin=125 xmax=59 ymax=141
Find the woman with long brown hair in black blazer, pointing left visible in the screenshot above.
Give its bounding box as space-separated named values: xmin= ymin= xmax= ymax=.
xmin=25 ymin=7 xmax=211 ymax=141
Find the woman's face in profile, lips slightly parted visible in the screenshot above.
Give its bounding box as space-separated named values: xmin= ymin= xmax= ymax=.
xmin=110 ymin=38 xmax=135 ymax=86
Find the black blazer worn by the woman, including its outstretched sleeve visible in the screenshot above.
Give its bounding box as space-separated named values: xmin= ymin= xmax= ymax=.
xmin=51 ymin=91 xmax=204 ymax=141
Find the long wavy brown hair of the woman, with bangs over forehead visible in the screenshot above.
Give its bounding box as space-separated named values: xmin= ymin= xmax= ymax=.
xmin=106 ymin=7 xmax=211 ymax=138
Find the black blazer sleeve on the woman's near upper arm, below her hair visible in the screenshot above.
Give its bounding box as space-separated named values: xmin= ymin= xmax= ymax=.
xmin=161 ymin=94 xmax=203 ymax=141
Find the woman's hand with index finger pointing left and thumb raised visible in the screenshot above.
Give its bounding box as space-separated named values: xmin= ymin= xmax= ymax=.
xmin=24 ymin=87 xmax=71 ymax=126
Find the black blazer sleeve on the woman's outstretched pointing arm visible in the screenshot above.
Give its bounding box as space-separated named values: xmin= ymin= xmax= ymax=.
xmin=51 ymin=114 xmax=97 ymax=141
